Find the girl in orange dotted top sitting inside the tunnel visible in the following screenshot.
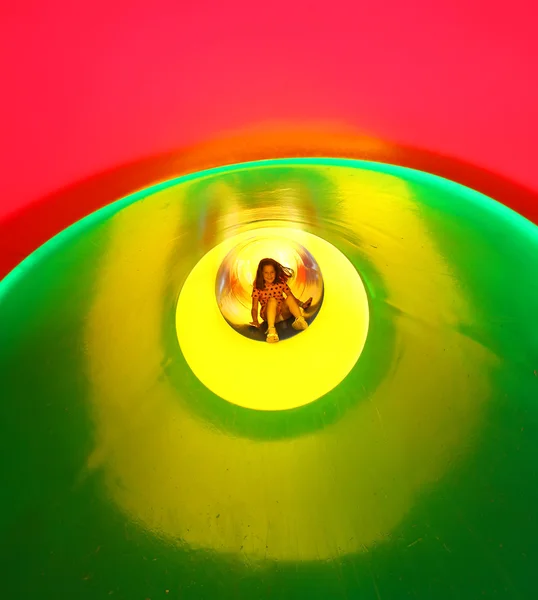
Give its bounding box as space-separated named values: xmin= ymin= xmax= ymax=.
xmin=250 ymin=258 xmax=312 ymax=343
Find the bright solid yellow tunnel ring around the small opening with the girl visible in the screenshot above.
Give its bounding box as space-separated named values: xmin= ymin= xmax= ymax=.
xmin=176 ymin=227 xmax=369 ymax=411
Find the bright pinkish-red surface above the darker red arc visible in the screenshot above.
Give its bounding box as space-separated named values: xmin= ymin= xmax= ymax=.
xmin=0 ymin=0 xmax=538 ymax=219
